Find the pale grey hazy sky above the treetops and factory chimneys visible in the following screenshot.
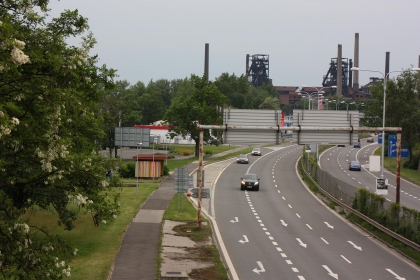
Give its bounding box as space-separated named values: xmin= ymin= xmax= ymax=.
xmin=50 ymin=0 xmax=420 ymax=86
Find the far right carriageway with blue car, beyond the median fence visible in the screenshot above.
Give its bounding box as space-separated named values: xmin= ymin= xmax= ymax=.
xmin=319 ymin=137 xmax=420 ymax=211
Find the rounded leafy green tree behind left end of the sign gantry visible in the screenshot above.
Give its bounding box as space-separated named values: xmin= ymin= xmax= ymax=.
xmin=164 ymin=75 xmax=226 ymax=156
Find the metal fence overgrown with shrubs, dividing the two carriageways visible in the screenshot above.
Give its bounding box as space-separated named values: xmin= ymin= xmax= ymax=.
xmin=302 ymin=153 xmax=420 ymax=250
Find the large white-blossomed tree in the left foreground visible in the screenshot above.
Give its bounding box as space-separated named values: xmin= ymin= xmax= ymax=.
xmin=0 ymin=0 xmax=119 ymax=279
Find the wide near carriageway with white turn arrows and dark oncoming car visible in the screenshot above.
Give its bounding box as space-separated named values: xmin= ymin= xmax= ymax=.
xmin=213 ymin=144 xmax=420 ymax=280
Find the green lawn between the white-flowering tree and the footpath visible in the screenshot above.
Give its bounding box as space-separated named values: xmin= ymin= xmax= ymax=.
xmin=21 ymin=184 xmax=158 ymax=280
